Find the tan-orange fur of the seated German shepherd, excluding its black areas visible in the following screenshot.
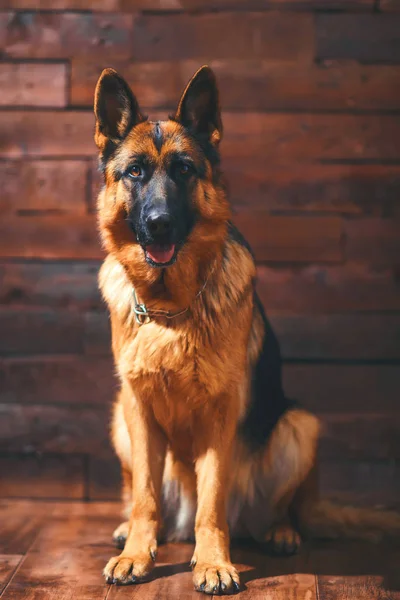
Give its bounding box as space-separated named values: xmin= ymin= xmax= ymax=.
xmin=95 ymin=70 xmax=398 ymax=593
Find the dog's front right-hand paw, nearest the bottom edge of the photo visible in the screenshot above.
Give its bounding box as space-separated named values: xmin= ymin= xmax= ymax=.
xmin=192 ymin=561 xmax=240 ymax=594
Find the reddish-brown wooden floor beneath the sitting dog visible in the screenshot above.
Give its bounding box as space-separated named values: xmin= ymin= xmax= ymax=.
xmin=0 ymin=500 xmax=400 ymax=600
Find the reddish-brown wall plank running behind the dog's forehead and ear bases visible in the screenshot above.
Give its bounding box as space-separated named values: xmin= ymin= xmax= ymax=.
xmin=0 ymin=110 xmax=400 ymax=164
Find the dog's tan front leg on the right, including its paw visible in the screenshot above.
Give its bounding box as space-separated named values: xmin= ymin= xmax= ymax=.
xmin=191 ymin=398 xmax=239 ymax=594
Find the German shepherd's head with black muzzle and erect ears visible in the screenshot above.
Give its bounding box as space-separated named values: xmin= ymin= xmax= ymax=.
xmin=94 ymin=67 xmax=229 ymax=268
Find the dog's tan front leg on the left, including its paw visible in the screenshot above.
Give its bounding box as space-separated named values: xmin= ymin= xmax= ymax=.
xmin=104 ymin=394 xmax=167 ymax=585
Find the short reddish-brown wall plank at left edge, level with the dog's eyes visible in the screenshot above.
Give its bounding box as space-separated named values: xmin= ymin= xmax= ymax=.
xmin=0 ymin=160 xmax=88 ymax=214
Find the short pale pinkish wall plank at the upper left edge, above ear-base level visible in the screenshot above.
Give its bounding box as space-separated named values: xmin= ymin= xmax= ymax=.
xmin=0 ymin=63 xmax=67 ymax=107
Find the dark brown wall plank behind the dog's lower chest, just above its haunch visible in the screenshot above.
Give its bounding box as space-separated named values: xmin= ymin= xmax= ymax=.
xmin=0 ymin=358 xmax=400 ymax=414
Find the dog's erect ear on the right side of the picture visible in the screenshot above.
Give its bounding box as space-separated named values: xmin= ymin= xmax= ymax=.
xmin=174 ymin=66 xmax=222 ymax=144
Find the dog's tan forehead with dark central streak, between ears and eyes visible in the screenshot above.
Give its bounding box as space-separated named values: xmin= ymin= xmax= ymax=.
xmin=119 ymin=120 xmax=201 ymax=162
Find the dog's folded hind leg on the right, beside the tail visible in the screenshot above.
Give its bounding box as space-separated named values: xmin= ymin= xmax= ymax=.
xmin=232 ymin=409 xmax=319 ymax=555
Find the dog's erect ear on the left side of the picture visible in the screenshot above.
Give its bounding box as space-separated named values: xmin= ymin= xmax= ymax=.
xmin=94 ymin=69 xmax=144 ymax=150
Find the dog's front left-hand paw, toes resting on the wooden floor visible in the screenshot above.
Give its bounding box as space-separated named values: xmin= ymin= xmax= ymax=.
xmin=104 ymin=548 xmax=156 ymax=585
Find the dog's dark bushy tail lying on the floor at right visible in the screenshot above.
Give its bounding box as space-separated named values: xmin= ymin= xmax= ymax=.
xmin=301 ymin=500 xmax=400 ymax=542
